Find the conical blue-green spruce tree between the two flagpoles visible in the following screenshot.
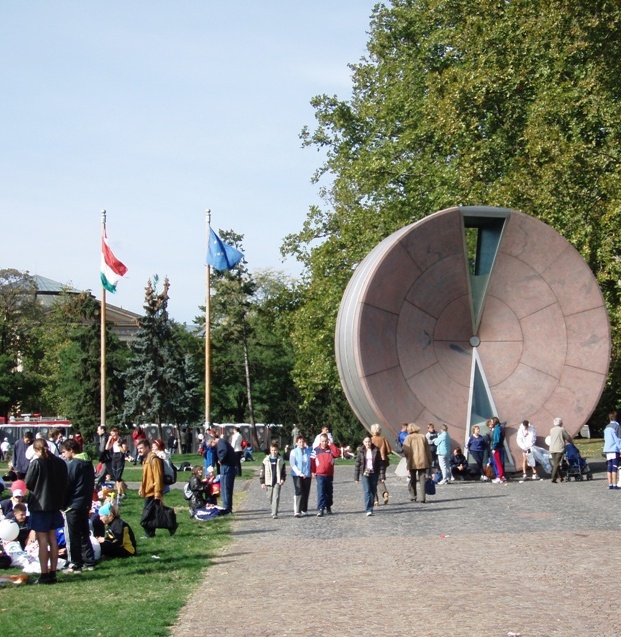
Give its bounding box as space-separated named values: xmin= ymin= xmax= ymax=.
xmin=122 ymin=276 xmax=199 ymax=437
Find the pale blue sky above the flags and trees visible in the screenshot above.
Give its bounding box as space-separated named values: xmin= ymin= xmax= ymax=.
xmin=0 ymin=0 xmax=376 ymax=323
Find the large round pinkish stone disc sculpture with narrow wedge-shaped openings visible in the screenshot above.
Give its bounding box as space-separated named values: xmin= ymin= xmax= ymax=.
xmin=336 ymin=207 xmax=610 ymax=464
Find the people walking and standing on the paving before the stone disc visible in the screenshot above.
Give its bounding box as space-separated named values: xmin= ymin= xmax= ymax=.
xmin=252 ymin=412 xmax=600 ymax=518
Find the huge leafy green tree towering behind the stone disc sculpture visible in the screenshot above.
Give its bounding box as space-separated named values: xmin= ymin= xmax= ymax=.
xmin=283 ymin=0 xmax=621 ymax=424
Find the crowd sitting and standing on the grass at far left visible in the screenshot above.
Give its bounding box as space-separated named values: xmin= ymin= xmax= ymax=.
xmin=0 ymin=426 xmax=184 ymax=584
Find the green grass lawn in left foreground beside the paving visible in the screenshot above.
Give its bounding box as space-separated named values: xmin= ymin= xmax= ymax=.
xmin=0 ymin=454 xmax=263 ymax=637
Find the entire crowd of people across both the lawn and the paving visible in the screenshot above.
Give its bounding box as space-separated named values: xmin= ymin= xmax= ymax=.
xmin=0 ymin=412 xmax=621 ymax=584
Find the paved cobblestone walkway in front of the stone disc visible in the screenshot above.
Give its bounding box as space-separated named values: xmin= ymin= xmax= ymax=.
xmin=172 ymin=466 xmax=621 ymax=637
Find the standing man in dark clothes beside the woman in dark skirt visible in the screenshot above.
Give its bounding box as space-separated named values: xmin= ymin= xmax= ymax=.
xmin=62 ymin=439 xmax=95 ymax=573
